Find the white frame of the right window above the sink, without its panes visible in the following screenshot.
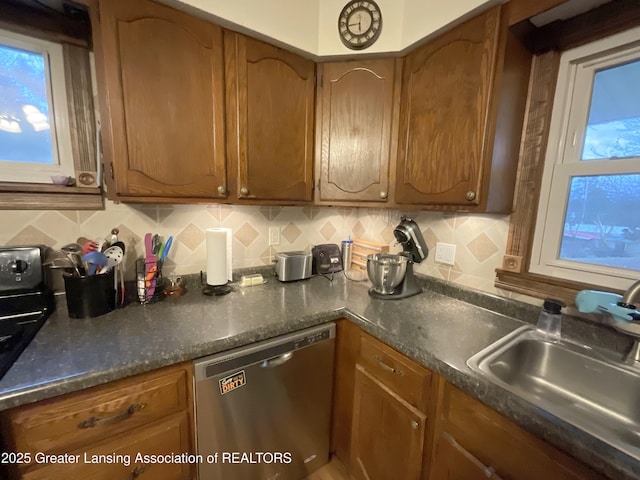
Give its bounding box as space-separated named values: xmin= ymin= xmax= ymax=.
xmin=529 ymin=24 xmax=640 ymax=290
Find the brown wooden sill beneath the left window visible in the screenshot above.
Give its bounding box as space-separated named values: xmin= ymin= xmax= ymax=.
xmin=0 ymin=183 xmax=104 ymax=210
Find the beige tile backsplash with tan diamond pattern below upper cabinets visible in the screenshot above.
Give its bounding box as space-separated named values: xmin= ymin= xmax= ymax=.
xmin=0 ymin=201 xmax=526 ymax=300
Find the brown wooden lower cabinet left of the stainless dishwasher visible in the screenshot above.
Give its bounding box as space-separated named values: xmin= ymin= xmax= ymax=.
xmin=0 ymin=363 xmax=195 ymax=480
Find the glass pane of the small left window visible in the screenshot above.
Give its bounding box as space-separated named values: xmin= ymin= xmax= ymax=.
xmin=0 ymin=45 xmax=53 ymax=164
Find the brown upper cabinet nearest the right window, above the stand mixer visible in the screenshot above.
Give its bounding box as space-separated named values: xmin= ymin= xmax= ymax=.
xmin=395 ymin=6 xmax=531 ymax=213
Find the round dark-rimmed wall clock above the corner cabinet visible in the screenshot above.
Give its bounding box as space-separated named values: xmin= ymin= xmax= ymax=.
xmin=338 ymin=0 xmax=382 ymax=50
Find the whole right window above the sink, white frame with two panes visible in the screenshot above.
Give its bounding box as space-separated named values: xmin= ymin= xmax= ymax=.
xmin=529 ymin=28 xmax=640 ymax=289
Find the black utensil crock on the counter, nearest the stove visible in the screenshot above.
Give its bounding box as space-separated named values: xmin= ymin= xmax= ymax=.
xmin=63 ymin=269 xmax=116 ymax=318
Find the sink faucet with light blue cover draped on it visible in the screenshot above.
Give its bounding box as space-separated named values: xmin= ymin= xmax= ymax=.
xmin=576 ymin=280 xmax=640 ymax=367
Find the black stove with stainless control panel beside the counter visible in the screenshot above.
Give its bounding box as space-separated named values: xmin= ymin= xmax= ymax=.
xmin=0 ymin=246 xmax=54 ymax=378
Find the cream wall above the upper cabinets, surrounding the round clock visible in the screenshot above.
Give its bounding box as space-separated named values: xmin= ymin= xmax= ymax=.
xmin=168 ymin=0 xmax=497 ymax=57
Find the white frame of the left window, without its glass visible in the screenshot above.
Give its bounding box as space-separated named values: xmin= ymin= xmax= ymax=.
xmin=0 ymin=29 xmax=74 ymax=184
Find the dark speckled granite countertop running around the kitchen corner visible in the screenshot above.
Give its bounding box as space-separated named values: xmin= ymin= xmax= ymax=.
xmin=0 ymin=274 xmax=640 ymax=480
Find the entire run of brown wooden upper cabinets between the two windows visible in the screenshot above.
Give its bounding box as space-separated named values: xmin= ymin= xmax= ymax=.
xmin=90 ymin=0 xmax=531 ymax=213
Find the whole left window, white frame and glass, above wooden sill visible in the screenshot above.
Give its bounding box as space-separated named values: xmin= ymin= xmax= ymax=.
xmin=0 ymin=30 xmax=74 ymax=183
